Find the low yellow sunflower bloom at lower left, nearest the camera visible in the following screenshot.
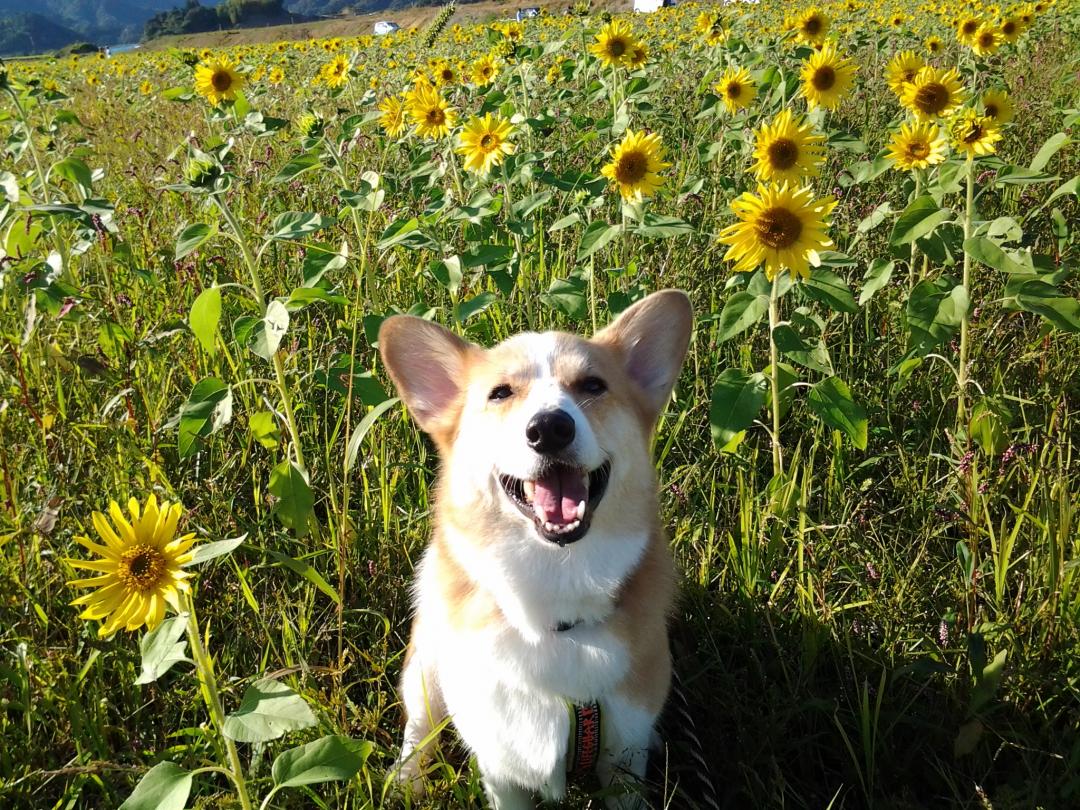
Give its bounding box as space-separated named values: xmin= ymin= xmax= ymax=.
xmin=67 ymin=495 xmax=195 ymax=636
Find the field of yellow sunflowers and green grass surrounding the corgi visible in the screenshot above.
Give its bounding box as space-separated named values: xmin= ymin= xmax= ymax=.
xmin=0 ymin=0 xmax=1080 ymax=810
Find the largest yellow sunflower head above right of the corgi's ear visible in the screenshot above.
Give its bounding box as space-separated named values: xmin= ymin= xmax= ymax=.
xmin=719 ymin=183 xmax=836 ymax=281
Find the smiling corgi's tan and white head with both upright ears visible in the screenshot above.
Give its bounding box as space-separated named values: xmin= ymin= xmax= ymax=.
xmin=379 ymin=289 xmax=693 ymax=545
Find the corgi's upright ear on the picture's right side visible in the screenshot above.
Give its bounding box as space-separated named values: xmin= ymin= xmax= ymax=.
xmin=594 ymin=289 xmax=693 ymax=418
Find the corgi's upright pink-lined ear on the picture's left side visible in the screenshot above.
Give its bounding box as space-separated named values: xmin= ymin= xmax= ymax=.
xmin=379 ymin=315 xmax=476 ymax=437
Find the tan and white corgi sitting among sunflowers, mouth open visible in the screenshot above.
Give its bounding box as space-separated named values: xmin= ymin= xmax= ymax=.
xmin=379 ymin=289 xmax=693 ymax=810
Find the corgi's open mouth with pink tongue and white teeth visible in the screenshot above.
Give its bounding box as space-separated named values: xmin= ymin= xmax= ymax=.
xmin=499 ymin=461 xmax=611 ymax=545
